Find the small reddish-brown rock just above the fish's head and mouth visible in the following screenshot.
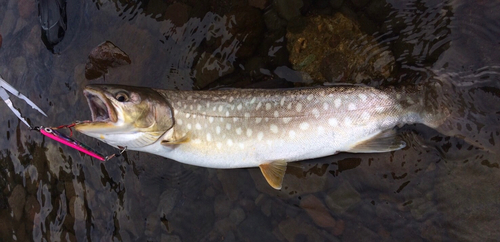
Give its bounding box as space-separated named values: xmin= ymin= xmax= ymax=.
xmin=85 ymin=41 xmax=132 ymax=80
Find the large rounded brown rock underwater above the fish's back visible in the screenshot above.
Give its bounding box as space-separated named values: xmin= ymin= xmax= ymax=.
xmin=286 ymin=13 xmax=394 ymax=83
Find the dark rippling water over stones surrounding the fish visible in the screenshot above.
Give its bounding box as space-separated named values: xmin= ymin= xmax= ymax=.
xmin=0 ymin=0 xmax=500 ymax=241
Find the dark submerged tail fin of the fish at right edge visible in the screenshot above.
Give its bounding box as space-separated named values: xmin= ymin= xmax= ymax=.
xmin=426 ymin=68 xmax=500 ymax=153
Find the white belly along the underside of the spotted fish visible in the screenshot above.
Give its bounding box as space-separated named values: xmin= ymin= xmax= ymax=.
xmin=134 ymin=118 xmax=382 ymax=169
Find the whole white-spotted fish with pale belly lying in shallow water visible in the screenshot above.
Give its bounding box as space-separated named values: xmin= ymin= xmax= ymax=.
xmin=75 ymin=84 xmax=450 ymax=190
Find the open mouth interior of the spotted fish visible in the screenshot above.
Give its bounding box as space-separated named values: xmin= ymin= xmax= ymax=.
xmin=83 ymin=89 xmax=117 ymax=123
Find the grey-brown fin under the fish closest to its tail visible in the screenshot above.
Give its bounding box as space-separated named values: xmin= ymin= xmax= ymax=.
xmin=348 ymin=129 xmax=406 ymax=153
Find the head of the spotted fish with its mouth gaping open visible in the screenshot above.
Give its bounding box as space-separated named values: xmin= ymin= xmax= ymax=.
xmin=75 ymin=85 xmax=174 ymax=149
